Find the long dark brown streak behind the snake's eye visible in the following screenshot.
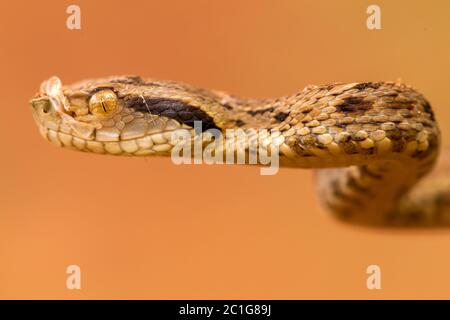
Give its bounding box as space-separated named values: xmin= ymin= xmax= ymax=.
xmin=122 ymin=96 xmax=221 ymax=131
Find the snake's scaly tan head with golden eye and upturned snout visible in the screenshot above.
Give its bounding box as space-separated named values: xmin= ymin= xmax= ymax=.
xmin=30 ymin=76 xmax=195 ymax=155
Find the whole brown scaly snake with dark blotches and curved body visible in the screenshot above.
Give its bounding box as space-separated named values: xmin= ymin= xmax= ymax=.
xmin=30 ymin=75 xmax=450 ymax=227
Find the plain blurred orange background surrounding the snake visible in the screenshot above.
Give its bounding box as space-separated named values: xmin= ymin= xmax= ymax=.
xmin=0 ymin=0 xmax=450 ymax=299
